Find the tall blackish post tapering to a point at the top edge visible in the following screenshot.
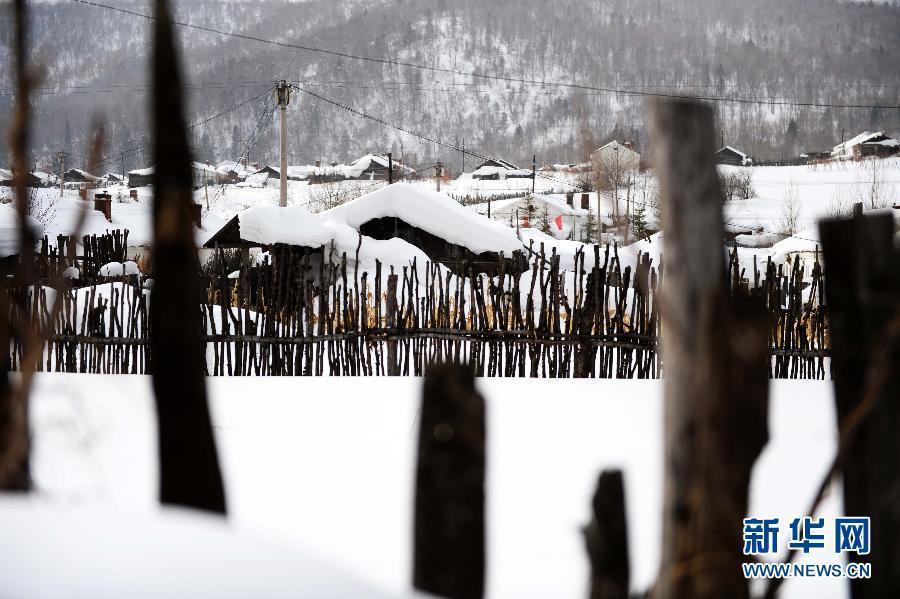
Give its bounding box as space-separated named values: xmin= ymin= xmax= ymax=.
xmin=150 ymin=0 xmax=225 ymax=513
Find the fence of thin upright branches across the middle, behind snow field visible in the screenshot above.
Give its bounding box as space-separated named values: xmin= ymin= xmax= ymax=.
xmin=5 ymin=232 xmax=830 ymax=379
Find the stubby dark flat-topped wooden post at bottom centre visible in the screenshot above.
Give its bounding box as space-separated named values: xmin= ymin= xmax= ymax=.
xmin=413 ymin=364 xmax=485 ymax=599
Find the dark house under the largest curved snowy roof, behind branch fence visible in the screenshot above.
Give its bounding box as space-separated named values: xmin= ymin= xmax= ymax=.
xmin=318 ymin=183 xmax=525 ymax=273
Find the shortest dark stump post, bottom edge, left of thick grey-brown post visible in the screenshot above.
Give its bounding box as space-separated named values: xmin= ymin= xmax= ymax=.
xmin=584 ymin=470 xmax=629 ymax=599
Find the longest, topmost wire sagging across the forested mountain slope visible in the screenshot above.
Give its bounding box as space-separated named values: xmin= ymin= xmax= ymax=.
xmin=74 ymin=0 xmax=900 ymax=110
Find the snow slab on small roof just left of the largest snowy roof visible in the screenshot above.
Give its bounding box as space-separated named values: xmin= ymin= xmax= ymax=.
xmin=238 ymin=206 xmax=331 ymax=247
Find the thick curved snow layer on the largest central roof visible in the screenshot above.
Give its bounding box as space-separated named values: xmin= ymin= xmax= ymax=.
xmin=319 ymin=183 xmax=522 ymax=254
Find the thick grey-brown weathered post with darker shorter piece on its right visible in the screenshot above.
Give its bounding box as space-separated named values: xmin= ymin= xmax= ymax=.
xmin=653 ymin=101 xmax=768 ymax=599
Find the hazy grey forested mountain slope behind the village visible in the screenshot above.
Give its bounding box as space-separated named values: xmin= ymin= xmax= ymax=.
xmin=0 ymin=0 xmax=900 ymax=170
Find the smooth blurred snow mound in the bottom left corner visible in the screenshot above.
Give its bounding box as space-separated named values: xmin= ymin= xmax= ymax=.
xmin=0 ymin=498 xmax=396 ymax=599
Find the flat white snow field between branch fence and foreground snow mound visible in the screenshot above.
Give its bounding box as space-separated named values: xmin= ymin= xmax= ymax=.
xmin=0 ymin=374 xmax=847 ymax=599
